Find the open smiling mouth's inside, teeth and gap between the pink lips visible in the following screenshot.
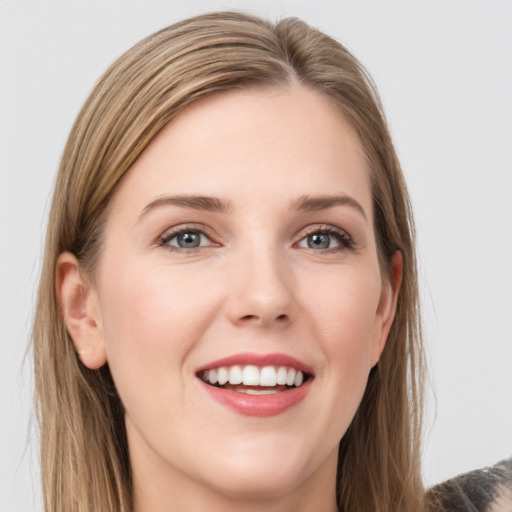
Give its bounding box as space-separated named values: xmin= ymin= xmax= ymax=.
xmin=198 ymin=365 xmax=311 ymax=395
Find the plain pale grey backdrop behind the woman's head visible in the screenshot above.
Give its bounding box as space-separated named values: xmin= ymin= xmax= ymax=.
xmin=0 ymin=0 xmax=512 ymax=512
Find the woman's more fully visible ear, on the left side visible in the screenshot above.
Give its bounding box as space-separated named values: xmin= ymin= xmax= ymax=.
xmin=55 ymin=252 xmax=107 ymax=370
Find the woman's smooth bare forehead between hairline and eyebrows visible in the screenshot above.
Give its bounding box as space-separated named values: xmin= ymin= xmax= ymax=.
xmin=113 ymin=85 xmax=372 ymax=218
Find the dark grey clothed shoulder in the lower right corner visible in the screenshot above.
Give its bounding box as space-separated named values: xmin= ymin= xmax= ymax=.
xmin=427 ymin=458 xmax=512 ymax=512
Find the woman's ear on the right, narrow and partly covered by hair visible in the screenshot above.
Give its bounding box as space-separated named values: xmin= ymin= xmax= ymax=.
xmin=372 ymin=251 xmax=403 ymax=367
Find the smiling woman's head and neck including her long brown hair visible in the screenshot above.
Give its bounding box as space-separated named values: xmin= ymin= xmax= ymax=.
xmin=34 ymin=9 xmax=424 ymax=512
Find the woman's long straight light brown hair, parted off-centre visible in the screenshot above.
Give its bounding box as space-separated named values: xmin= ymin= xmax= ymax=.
xmin=33 ymin=12 xmax=423 ymax=512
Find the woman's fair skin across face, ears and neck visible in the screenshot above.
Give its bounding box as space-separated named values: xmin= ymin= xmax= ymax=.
xmin=57 ymin=85 xmax=401 ymax=512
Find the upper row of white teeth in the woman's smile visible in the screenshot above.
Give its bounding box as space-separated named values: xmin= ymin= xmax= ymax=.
xmin=200 ymin=365 xmax=304 ymax=388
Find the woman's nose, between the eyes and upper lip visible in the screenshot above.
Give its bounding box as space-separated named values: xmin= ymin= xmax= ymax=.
xmin=226 ymin=245 xmax=297 ymax=327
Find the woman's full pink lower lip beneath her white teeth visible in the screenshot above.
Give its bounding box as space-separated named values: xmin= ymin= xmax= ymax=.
xmin=201 ymin=379 xmax=313 ymax=418
